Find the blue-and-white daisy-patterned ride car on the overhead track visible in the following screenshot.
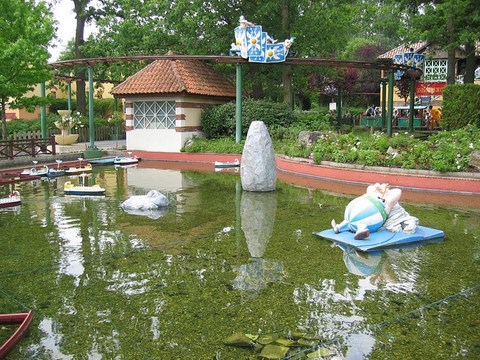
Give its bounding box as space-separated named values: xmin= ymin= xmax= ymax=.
xmin=230 ymin=15 xmax=294 ymax=63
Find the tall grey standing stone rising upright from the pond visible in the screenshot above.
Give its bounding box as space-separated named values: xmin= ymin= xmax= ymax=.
xmin=240 ymin=121 xmax=277 ymax=191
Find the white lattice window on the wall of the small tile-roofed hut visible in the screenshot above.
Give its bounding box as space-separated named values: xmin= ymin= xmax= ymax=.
xmin=133 ymin=101 xmax=175 ymax=129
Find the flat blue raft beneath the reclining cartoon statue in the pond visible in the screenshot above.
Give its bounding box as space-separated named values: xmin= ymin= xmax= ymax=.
xmin=314 ymin=226 xmax=445 ymax=251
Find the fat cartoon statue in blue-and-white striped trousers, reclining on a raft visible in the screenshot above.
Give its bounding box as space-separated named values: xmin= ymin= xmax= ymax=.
xmin=331 ymin=183 xmax=418 ymax=240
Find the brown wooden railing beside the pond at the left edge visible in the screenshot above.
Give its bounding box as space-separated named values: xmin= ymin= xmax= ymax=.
xmin=0 ymin=136 xmax=56 ymax=159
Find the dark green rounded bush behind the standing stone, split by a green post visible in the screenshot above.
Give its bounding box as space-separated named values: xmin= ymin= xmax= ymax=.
xmin=201 ymin=99 xmax=297 ymax=139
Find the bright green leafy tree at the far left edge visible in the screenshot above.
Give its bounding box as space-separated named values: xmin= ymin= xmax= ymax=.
xmin=0 ymin=0 xmax=54 ymax=139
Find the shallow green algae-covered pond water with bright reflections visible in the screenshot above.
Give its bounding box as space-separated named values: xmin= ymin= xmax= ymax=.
xmin=0 ymin=164 xmax=480 ymax=359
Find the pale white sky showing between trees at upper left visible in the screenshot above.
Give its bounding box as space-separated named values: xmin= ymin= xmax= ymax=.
xmin=48 ymin=0 xmax=94 ymax=62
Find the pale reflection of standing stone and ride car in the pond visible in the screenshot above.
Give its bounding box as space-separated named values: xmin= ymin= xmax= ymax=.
xmin=233 ymin=191 xmax=285 ymax=292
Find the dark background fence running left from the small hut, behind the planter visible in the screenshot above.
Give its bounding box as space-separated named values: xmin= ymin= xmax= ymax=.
xmin=13 ymin=126 xmax=126 ymax=142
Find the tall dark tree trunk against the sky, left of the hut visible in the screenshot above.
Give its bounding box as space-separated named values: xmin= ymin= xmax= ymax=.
xmin=73 ymin=0 xmax=88 ymax=115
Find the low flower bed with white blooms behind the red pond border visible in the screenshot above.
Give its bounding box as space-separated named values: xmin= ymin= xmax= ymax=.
xmin=306 ymin=126 xmax=480 ymax=172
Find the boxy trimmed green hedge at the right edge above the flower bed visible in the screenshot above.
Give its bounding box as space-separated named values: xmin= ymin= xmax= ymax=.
xmin=442 ymin=84 xmax=480 ymax=130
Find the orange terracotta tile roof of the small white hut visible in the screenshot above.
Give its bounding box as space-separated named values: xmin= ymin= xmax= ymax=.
xmin=111 ymin=59 xmax=235 ymax=97
